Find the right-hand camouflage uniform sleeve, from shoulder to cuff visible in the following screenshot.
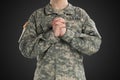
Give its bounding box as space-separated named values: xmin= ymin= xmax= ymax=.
xmin=62 ymin=10 xmax=101 ymax=55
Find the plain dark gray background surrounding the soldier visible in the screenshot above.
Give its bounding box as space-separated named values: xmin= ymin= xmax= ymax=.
xmin=0 ymin=0 xmax=120 ymax=80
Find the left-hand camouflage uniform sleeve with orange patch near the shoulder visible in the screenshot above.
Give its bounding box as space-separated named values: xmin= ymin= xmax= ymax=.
xmin=18 ymin=12 xmax=51 ymax=58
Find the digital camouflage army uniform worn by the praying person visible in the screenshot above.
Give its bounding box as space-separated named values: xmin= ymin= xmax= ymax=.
xmin=19 ymin=4 xmax=101 ymax=80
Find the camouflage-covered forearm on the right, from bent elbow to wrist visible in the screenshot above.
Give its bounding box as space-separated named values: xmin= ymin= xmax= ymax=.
xmin=61 ymin=29 xmax=101 ymax=55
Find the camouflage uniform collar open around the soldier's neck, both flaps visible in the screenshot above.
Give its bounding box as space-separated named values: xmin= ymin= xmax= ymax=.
xmin=45 ymin=3 xmax=74 ymax=15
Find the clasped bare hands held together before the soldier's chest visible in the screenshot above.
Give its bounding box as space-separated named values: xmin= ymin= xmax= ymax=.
xmin=52 ymin=17 xmax=66 ymax=37
